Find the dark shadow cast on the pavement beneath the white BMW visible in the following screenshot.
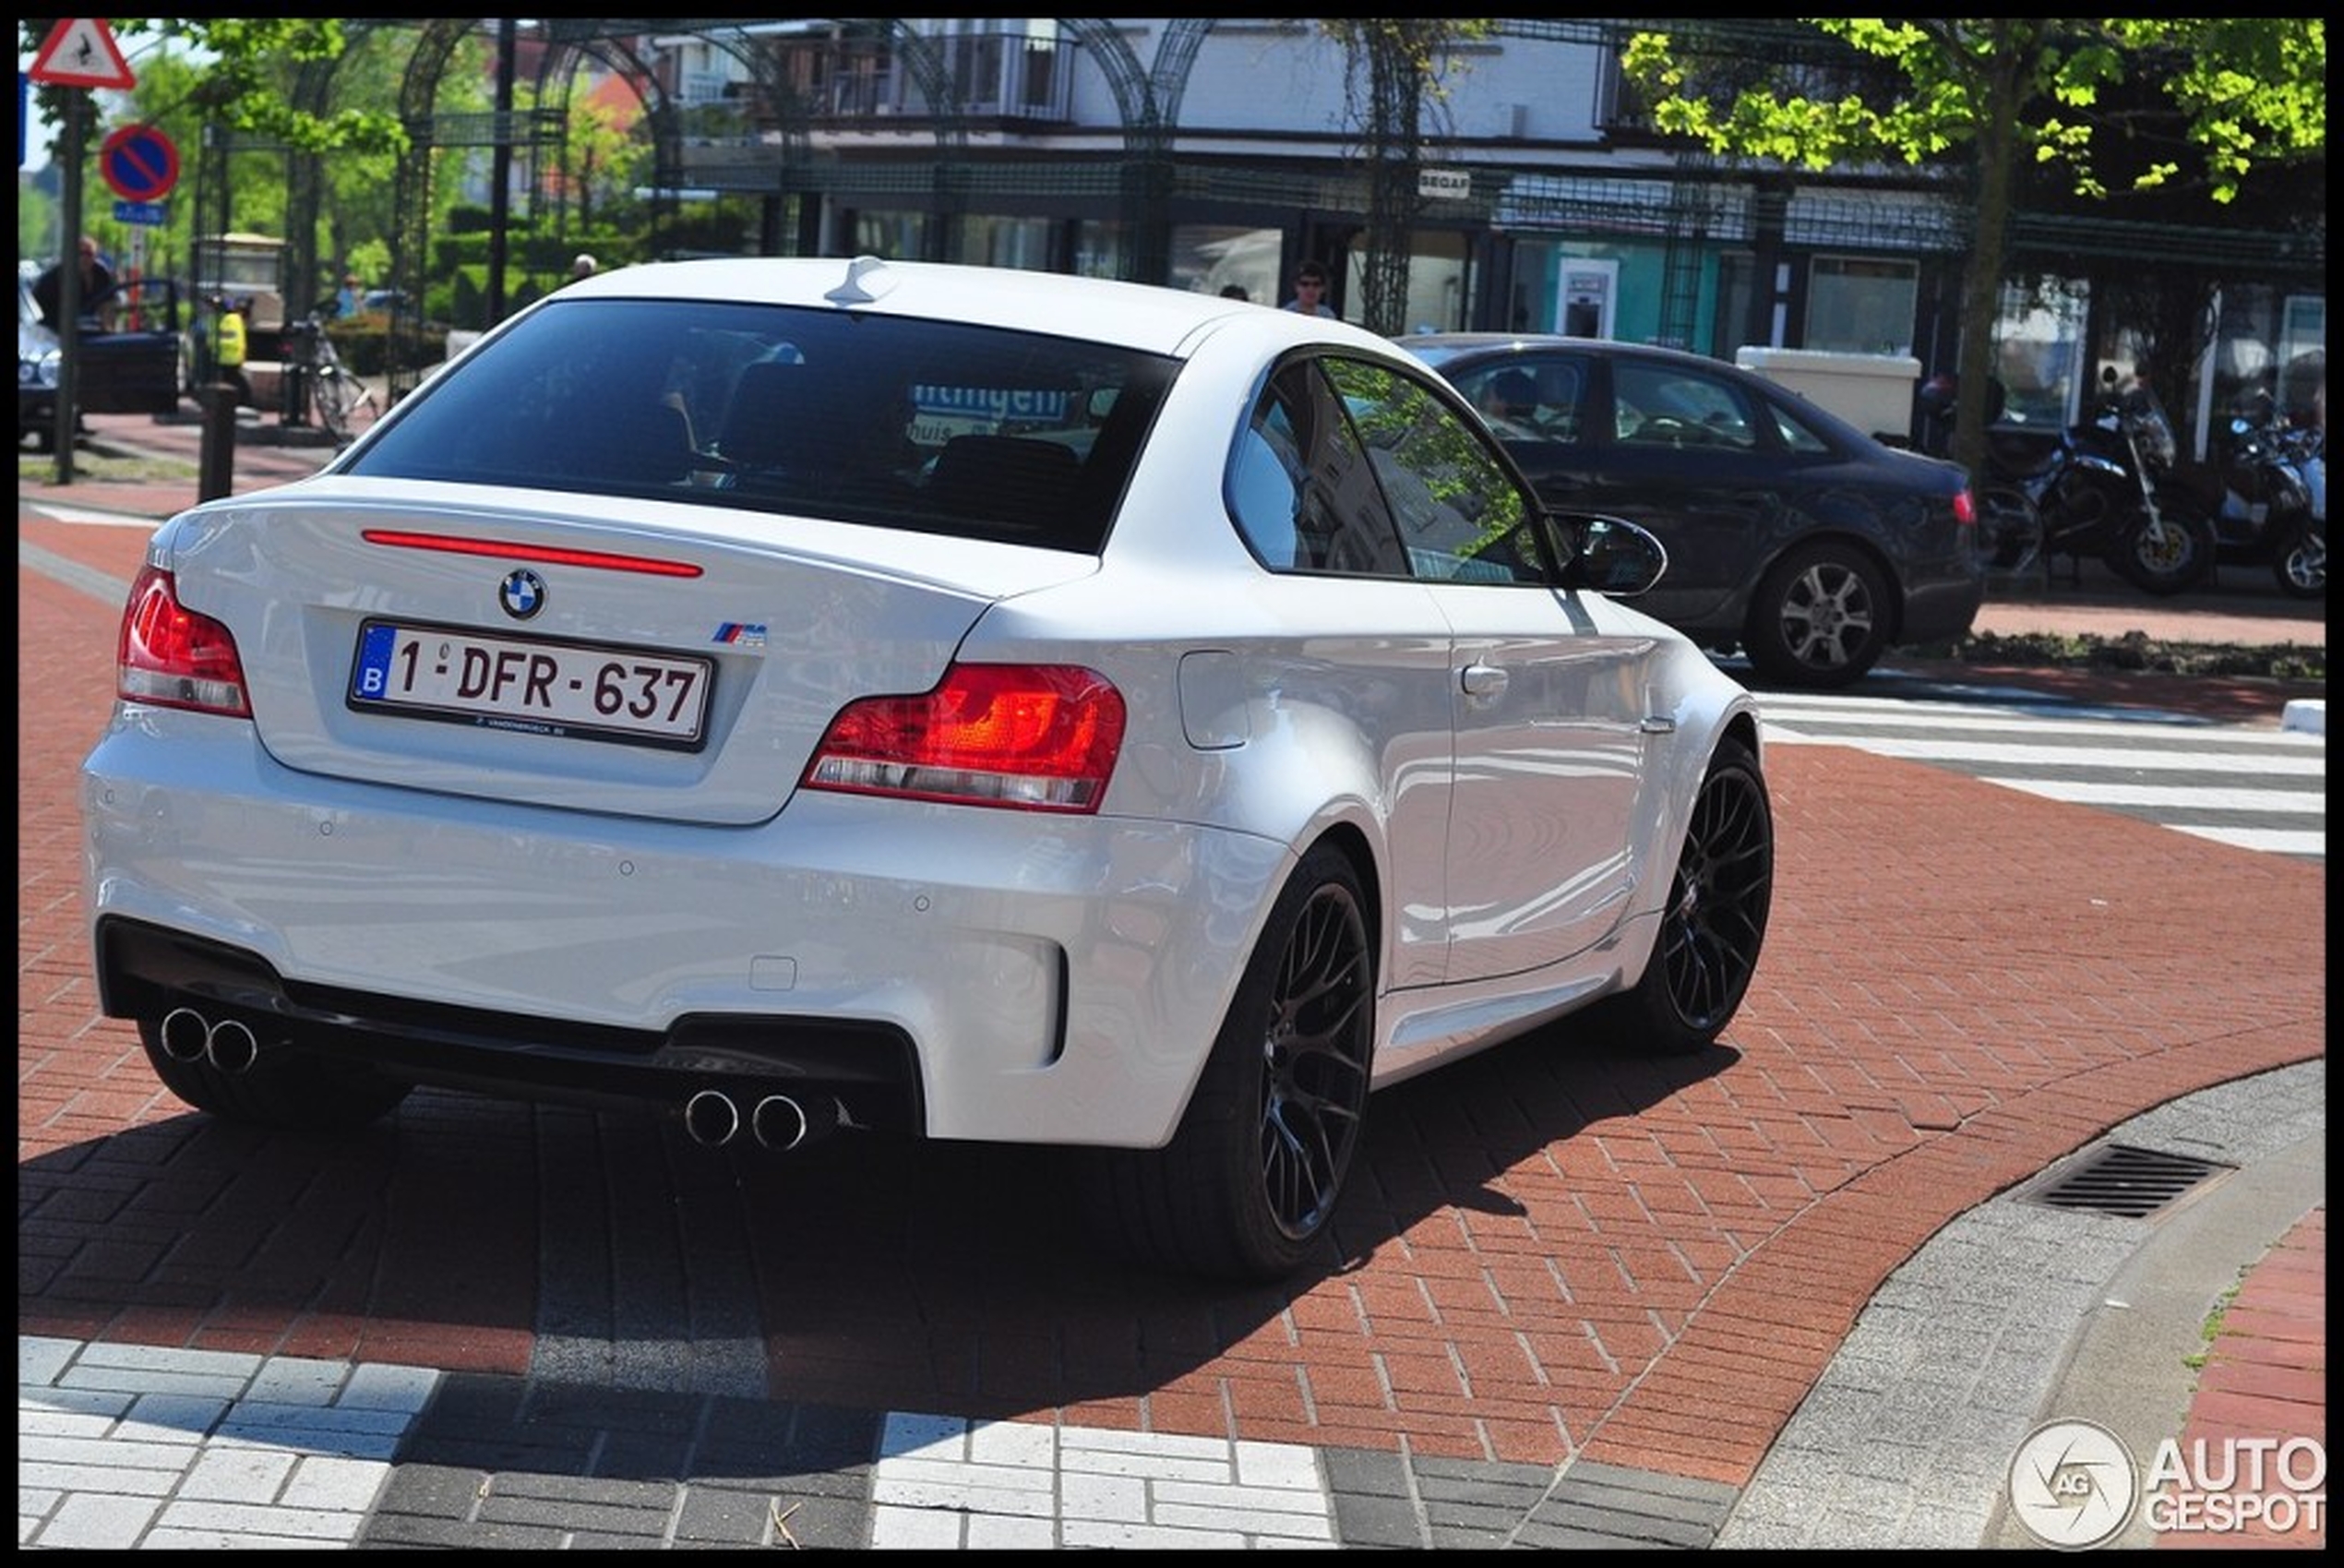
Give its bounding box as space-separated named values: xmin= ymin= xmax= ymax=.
xmin=18 ymin=1024 xmax=1737 ymax=1430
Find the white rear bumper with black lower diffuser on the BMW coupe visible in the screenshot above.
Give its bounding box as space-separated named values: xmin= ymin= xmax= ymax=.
xmin=82 ymin=708 xmax=1286 ymax=1146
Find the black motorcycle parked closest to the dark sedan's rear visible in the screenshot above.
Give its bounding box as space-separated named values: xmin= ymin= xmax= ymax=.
xmin=1979 ymin=370 xmax=2218 ymax=595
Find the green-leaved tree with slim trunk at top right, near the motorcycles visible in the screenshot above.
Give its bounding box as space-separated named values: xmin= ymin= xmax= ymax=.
xmin=1622 ymin=17 xmax=2327 ymax=485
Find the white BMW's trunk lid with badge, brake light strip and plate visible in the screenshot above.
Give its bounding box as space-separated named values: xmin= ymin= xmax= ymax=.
xmin=160 ymin=478 xmax=1097 ymax=825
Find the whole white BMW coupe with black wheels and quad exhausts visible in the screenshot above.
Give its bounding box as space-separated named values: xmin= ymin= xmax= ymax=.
xmin=82 ymin=257 xmax=1775 ymax=1280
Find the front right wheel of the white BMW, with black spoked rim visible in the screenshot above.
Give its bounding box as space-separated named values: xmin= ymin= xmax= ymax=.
xmin=1587 ymin=741 xmax=1775 ymax=1057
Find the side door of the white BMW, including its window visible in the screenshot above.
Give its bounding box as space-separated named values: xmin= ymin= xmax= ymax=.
xmin=1327 ymin=359 xmax=1659 ymax=982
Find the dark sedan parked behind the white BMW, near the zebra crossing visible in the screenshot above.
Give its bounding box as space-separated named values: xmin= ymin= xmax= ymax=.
xmin=1399 ymin=333 xmax=1983 ymax=687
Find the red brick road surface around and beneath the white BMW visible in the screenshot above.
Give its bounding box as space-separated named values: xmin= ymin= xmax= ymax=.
xmin=18 ymin=407 xmax=2326 ymax=1537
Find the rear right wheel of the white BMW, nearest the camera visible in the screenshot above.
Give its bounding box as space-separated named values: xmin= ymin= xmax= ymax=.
xmin=1082 ymin=844 xmax=1376 ymax=1282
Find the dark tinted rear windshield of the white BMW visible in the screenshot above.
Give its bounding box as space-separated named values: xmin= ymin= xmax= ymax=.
xmin=342 ymin=300 xmax=1175 ymax=551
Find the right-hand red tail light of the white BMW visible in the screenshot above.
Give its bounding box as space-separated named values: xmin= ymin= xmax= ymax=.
xmin=804 ymin=664 xmax=1123 ymax=813
